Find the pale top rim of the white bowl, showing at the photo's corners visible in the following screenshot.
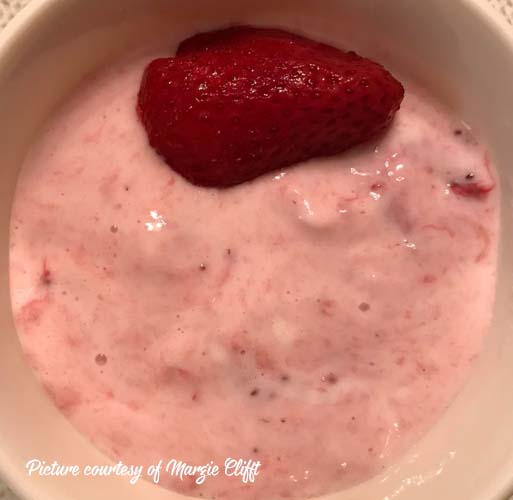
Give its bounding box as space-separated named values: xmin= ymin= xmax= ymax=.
xmin=0 ymin=0 xmax=513 ymax=500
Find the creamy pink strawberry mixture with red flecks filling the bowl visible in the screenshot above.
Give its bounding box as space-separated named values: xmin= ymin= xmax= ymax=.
xmin=11 ymin=51 xmax=498 ymax=500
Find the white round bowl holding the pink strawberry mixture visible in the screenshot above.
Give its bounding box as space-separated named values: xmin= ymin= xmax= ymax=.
xmin=0 ymin=0 xmax=513 ymax=500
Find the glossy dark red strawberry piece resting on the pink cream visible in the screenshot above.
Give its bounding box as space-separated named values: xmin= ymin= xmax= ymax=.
xmin=138 ymin=26 xmax=404 ymax=187
